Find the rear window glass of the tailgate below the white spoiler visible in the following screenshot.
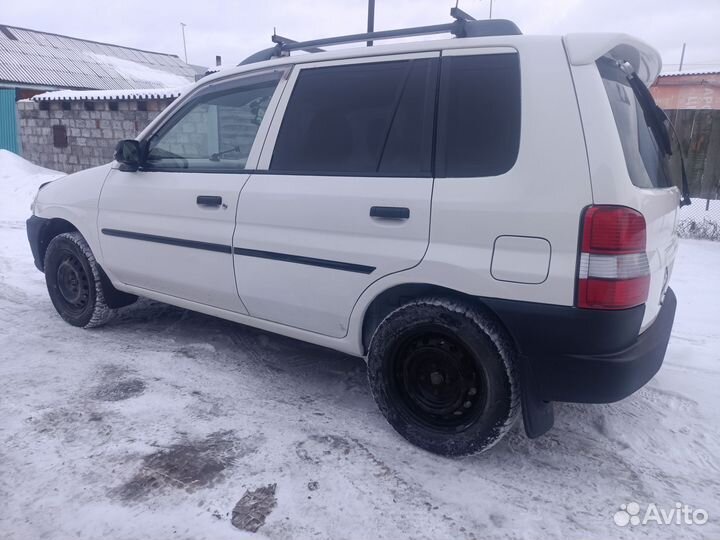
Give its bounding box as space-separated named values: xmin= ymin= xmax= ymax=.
xmin=597 ymin=57 xmax=682 ymax=189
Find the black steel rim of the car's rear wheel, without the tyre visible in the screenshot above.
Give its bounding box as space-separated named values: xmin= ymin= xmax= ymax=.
xmin=392 ymin=328 xmax=487 ymax=432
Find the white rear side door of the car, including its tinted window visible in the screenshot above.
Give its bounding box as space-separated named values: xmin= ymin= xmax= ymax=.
xmin=233 ymin=52 xmax=439 ymax=337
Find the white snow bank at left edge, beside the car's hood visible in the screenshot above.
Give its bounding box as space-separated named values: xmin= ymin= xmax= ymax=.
xmin=0 ymin=149 xmax=65 ymax=222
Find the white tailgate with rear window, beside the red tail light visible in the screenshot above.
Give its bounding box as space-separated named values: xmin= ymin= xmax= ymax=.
xmin=593 ymin=57 xmax=681 ymax=328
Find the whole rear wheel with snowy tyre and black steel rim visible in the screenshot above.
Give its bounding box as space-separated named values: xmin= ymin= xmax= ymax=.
xmin=368 ymin=298 xmax=520 ymax=456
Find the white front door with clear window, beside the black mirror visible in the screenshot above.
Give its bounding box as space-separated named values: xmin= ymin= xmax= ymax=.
xmin=98 ymin=71 xmax=290 ymax=313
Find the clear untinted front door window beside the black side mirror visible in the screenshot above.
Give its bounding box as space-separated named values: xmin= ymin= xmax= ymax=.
xmin=145 ymin=74 xmax=280 ymax=170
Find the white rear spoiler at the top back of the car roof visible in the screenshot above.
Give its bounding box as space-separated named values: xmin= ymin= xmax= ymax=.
xmin=563 ymin=34 xmax=662 ymax=87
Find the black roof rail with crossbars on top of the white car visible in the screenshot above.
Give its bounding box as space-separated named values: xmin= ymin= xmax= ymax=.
xmin=239 ymin=7 xmax=522 ymax=66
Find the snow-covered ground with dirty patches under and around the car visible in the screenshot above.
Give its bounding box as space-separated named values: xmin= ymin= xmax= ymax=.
xmin=0 ymin=153 xmax=720 ymax=540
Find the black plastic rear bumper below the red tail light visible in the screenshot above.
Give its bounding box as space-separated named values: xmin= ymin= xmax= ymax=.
xmin=486 ymin=289 xmax=677 ymax=403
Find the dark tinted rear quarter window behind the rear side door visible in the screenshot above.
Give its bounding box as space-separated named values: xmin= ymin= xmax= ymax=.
xmin=436 ymin=53 xmax=520 ymax=177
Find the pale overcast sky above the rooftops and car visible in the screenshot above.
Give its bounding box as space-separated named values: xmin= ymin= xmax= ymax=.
xmin=0 ymin=0 xmax=720 ymax=70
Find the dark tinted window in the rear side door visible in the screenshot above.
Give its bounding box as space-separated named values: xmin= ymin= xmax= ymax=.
xmin=270 ymin=59 xmax=437 ymax=176
